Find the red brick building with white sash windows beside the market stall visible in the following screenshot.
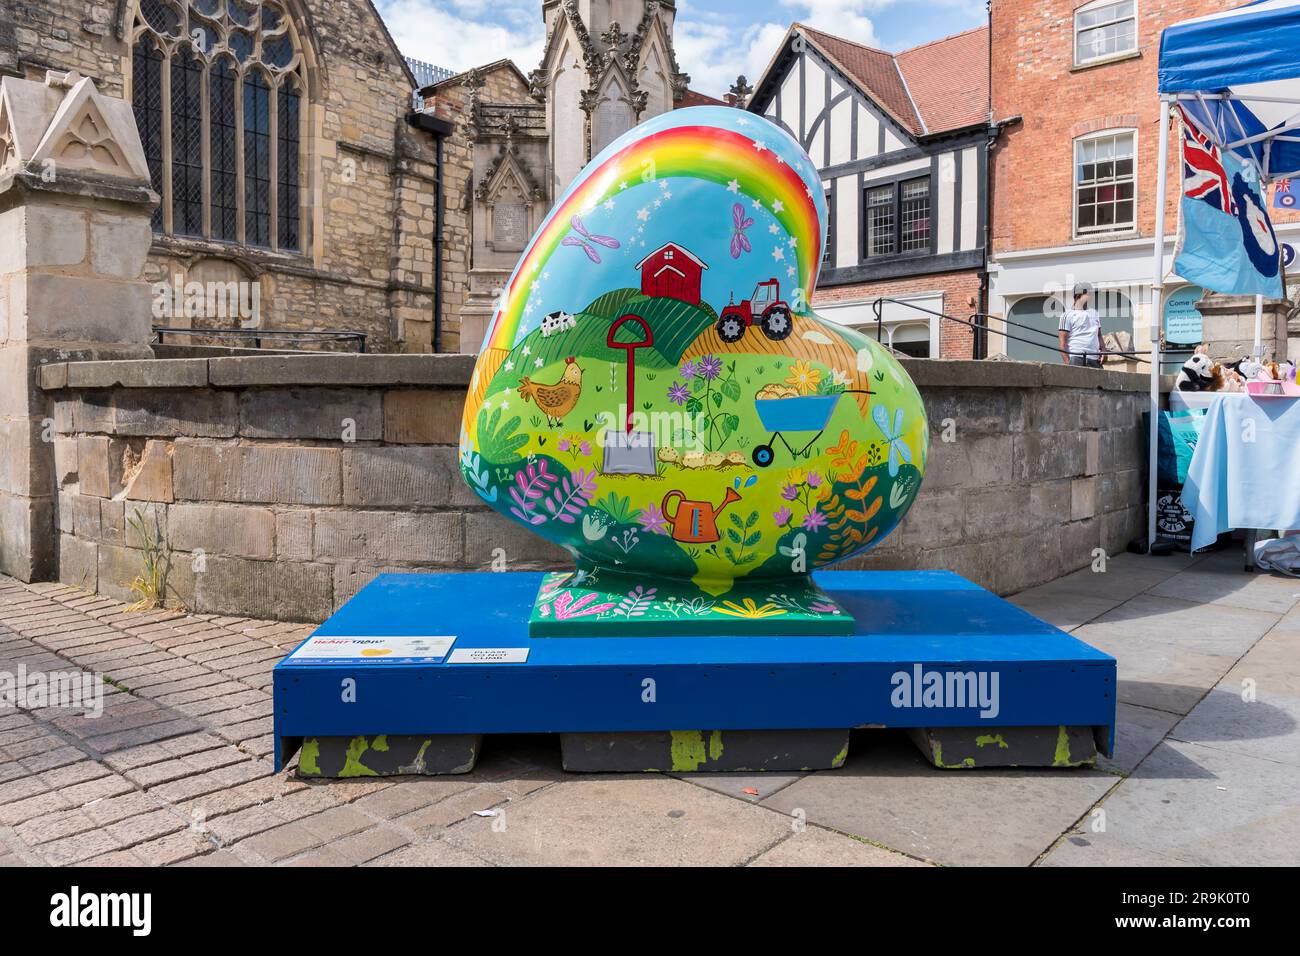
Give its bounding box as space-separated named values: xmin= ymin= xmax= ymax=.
xmin=988 ymin=0 xmax=1300 ymax=369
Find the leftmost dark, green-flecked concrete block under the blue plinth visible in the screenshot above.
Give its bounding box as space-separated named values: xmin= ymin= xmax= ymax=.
xmin=298 ymin=734 xmax=484 ymax=777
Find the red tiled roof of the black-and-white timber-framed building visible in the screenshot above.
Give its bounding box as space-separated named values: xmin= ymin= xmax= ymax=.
xmin=792 ymin=23 xmax=988 ymax=135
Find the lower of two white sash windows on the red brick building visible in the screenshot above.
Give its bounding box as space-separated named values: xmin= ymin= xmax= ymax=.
xmin=1074 ymin=130 xmax=1138 ymax=235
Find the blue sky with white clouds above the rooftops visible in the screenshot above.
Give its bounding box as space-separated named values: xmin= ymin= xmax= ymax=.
xmin=376 ymin=0 xmax=984 ymax=96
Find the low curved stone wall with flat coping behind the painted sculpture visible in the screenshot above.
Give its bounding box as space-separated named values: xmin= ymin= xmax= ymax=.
xmin=42 ymin=355 xmax=1145 ymax=620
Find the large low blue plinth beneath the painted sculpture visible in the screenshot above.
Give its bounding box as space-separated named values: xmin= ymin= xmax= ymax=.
xmin=273 ymin=571 xmax=1115 ymax=769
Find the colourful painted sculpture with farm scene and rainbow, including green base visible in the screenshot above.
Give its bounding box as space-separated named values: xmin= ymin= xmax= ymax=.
xmin=460 ymin=107 xmax=928 ymax=636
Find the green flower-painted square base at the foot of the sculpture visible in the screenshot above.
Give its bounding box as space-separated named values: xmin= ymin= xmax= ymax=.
xmin=528 ymin=567 xmax=854 ymax=637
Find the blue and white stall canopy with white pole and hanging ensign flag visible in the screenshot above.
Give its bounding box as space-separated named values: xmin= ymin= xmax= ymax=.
xmin=1147 ymin=0 xmax=1300 ymax=546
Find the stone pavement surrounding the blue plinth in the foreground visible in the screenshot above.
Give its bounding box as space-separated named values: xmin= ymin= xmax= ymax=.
xmin=0 ymin=551 xmax=1300 ymax=866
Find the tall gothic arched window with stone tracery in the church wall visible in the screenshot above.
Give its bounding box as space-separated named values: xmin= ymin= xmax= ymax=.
xmin=131 ymin=0 xmax=307 ymax=251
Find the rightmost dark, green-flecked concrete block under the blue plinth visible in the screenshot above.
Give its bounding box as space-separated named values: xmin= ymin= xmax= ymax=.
xmin=907 ymin=727 xmax=1097 ymax=770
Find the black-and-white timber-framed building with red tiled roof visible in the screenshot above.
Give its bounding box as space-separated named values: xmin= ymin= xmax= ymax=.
xmin=748 ymin=23 xmax=992 ymax=358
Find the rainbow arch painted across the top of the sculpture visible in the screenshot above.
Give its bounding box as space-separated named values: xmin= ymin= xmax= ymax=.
xmin=484 ymin=115 xmax=824 ymax=350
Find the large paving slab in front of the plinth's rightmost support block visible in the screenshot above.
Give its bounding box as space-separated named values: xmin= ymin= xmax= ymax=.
xmin=761 ymin=731 xmax=1115 ymax=866
